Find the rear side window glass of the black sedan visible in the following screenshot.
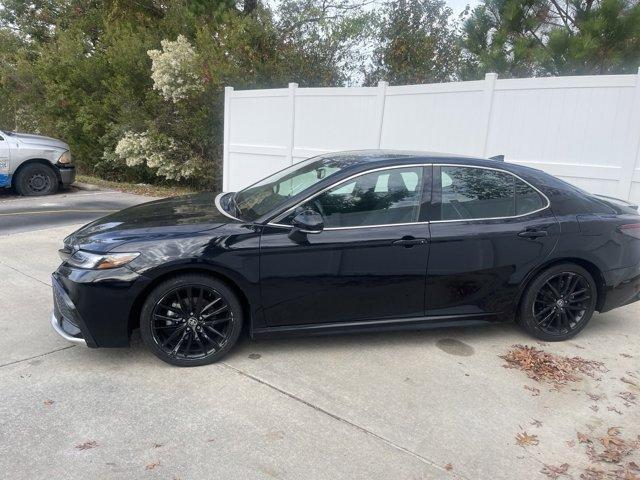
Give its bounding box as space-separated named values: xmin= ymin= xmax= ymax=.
xmin=433 ymin=166 xmax=545 ymax=220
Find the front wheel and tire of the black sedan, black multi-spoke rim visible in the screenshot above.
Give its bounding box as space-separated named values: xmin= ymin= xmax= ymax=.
xmin=140 ymin=274 xmax=243 ymax=367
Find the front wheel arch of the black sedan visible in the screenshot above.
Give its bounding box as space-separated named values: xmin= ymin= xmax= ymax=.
xmin=127 ymin=265 xmax=253 ymax=338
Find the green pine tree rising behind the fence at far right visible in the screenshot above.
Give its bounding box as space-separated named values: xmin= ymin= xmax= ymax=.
xmin=461 ymin=0 xmax=640 ymax=78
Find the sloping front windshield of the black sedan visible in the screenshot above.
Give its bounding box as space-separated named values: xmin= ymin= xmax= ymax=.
xmin=232 ymin=156 xmax=352 ymax=221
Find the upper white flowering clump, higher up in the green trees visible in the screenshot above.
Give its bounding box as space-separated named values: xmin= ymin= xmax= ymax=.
xmin=147 ymin=35 xmax=204 ymax=103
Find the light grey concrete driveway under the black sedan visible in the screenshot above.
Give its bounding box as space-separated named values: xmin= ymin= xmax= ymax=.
xmin=0 ymin=189 xmax=640 ymax=480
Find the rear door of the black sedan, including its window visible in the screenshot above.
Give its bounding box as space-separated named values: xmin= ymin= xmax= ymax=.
xmin=426 ymin=165 xmax=559 ymax=319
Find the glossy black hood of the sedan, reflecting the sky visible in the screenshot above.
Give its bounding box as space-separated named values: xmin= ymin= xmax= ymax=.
xmin=64 ymin=192 xmax=240 ymax=253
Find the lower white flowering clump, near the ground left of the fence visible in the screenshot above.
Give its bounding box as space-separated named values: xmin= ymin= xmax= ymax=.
xmin=115 ymin=131 xmax=202 ymax=180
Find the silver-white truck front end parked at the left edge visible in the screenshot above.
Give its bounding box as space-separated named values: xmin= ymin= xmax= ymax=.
xmin=0 ymin=130 xmax=76 ymax=195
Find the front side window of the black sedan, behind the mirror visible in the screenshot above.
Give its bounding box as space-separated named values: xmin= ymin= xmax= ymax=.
xmin=279 ymin=167 xmax=423 ymax=228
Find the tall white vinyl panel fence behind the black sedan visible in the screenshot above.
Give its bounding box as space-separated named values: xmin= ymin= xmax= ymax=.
xmin=223 ymin=70 xmax=640 ymax=202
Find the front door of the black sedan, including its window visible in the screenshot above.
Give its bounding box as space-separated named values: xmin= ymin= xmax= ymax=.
xmin=260 ymin=165 xmax=431 ymax=326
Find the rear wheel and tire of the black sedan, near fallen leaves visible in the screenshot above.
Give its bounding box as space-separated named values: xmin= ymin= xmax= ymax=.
xmin=518 ymin=263 xmax=598 ymax=342
